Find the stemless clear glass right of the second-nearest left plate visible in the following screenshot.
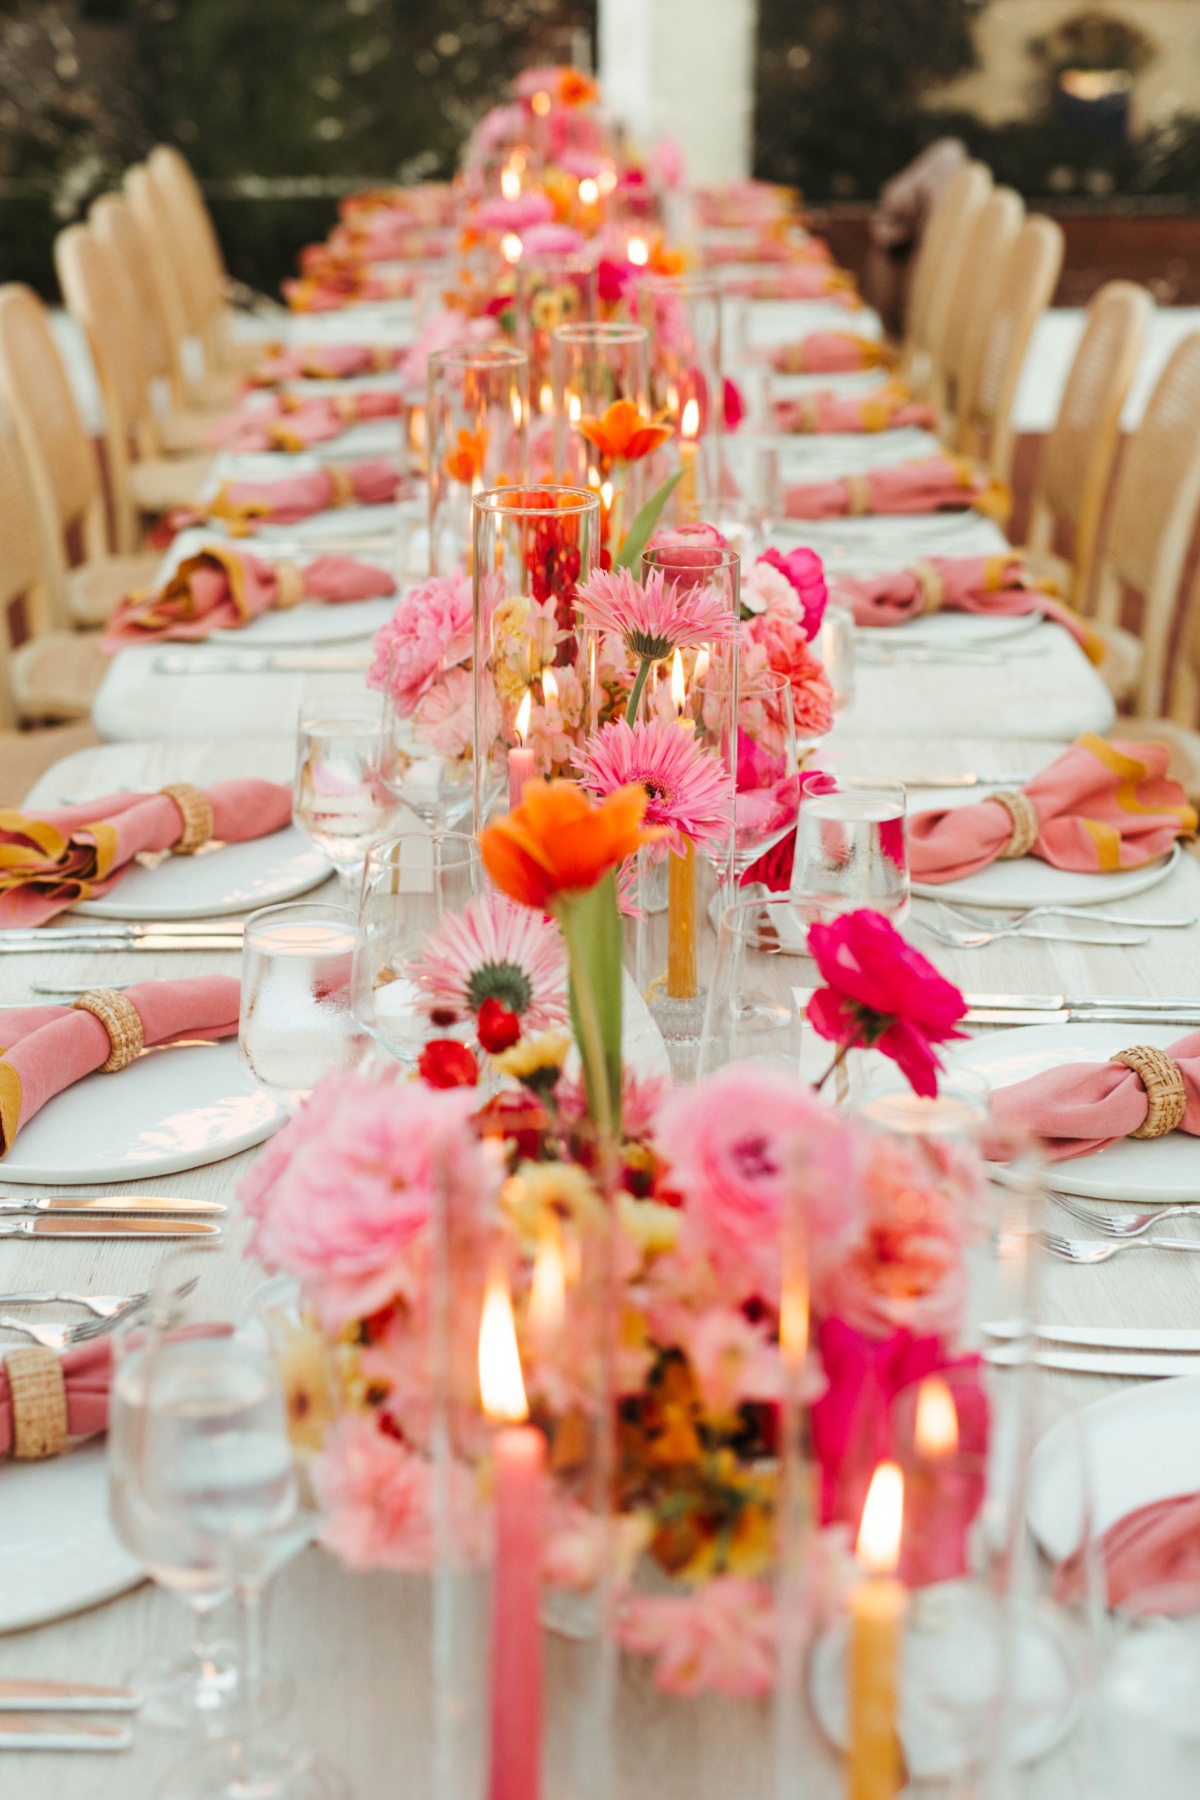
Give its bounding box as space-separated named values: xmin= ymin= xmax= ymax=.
xmin=237 ymin=900 xmax=367 ymax=1112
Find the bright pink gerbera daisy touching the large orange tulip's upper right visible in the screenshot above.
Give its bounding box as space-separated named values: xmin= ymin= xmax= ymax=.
xmin=576 ymin=718 xmax=734 ymax=855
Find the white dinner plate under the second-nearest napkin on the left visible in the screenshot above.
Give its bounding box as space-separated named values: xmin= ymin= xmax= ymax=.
xmin=0 ymin=1033 xmax=288 ymax=1188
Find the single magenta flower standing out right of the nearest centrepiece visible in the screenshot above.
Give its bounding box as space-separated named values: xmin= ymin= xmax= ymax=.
xmin=808 ymin=907 xmax=966 ymax=1098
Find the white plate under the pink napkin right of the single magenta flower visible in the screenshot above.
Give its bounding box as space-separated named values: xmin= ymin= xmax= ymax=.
xmin=949 ymin=1024 xmax=1200 ymax=1202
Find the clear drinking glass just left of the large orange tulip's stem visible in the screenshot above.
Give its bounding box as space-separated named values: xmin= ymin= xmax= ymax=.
xmin=353 ymin=832 xmax=484 ymax=1064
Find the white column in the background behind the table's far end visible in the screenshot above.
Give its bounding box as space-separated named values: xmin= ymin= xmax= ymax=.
xmin=599 ymin=0 xmax=756 ymax=182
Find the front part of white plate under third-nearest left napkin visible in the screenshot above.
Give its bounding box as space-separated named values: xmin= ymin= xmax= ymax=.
xmin=70 ymin=824 xmax=331 ymax=920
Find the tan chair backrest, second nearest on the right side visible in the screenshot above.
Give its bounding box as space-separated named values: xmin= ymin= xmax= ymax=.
xmin=1031 ymin=281 xmax=1153 ymax=610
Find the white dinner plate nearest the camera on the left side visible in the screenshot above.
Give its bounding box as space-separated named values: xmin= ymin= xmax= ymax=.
xmin=0 ymin=1440 xmax=146 ymax=1641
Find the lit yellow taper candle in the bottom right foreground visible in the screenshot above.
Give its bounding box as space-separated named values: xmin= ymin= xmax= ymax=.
xmin=846 ymin=1463 xmax=905 ymax=1800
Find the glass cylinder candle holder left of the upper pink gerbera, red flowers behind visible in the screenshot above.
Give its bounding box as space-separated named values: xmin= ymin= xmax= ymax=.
xmin=471 ymin=486 xmax=601 ymax=832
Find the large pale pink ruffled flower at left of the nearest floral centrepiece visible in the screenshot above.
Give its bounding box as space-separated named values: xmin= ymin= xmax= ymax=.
xmin=237 ymin=1069 xmax=497 ymax=1330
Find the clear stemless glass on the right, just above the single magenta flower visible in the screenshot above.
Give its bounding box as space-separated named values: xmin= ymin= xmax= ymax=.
xmin=792 ymin=776 xmax=909 ymax=923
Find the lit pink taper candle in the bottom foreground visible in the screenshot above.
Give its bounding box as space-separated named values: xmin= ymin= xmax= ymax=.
xmin=479 ymin=1278 xmax=545 ymax=1800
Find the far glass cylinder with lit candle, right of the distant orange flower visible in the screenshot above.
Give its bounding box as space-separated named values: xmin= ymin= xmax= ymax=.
xmin=637 ymin=275 xmax=725 ymax=524
